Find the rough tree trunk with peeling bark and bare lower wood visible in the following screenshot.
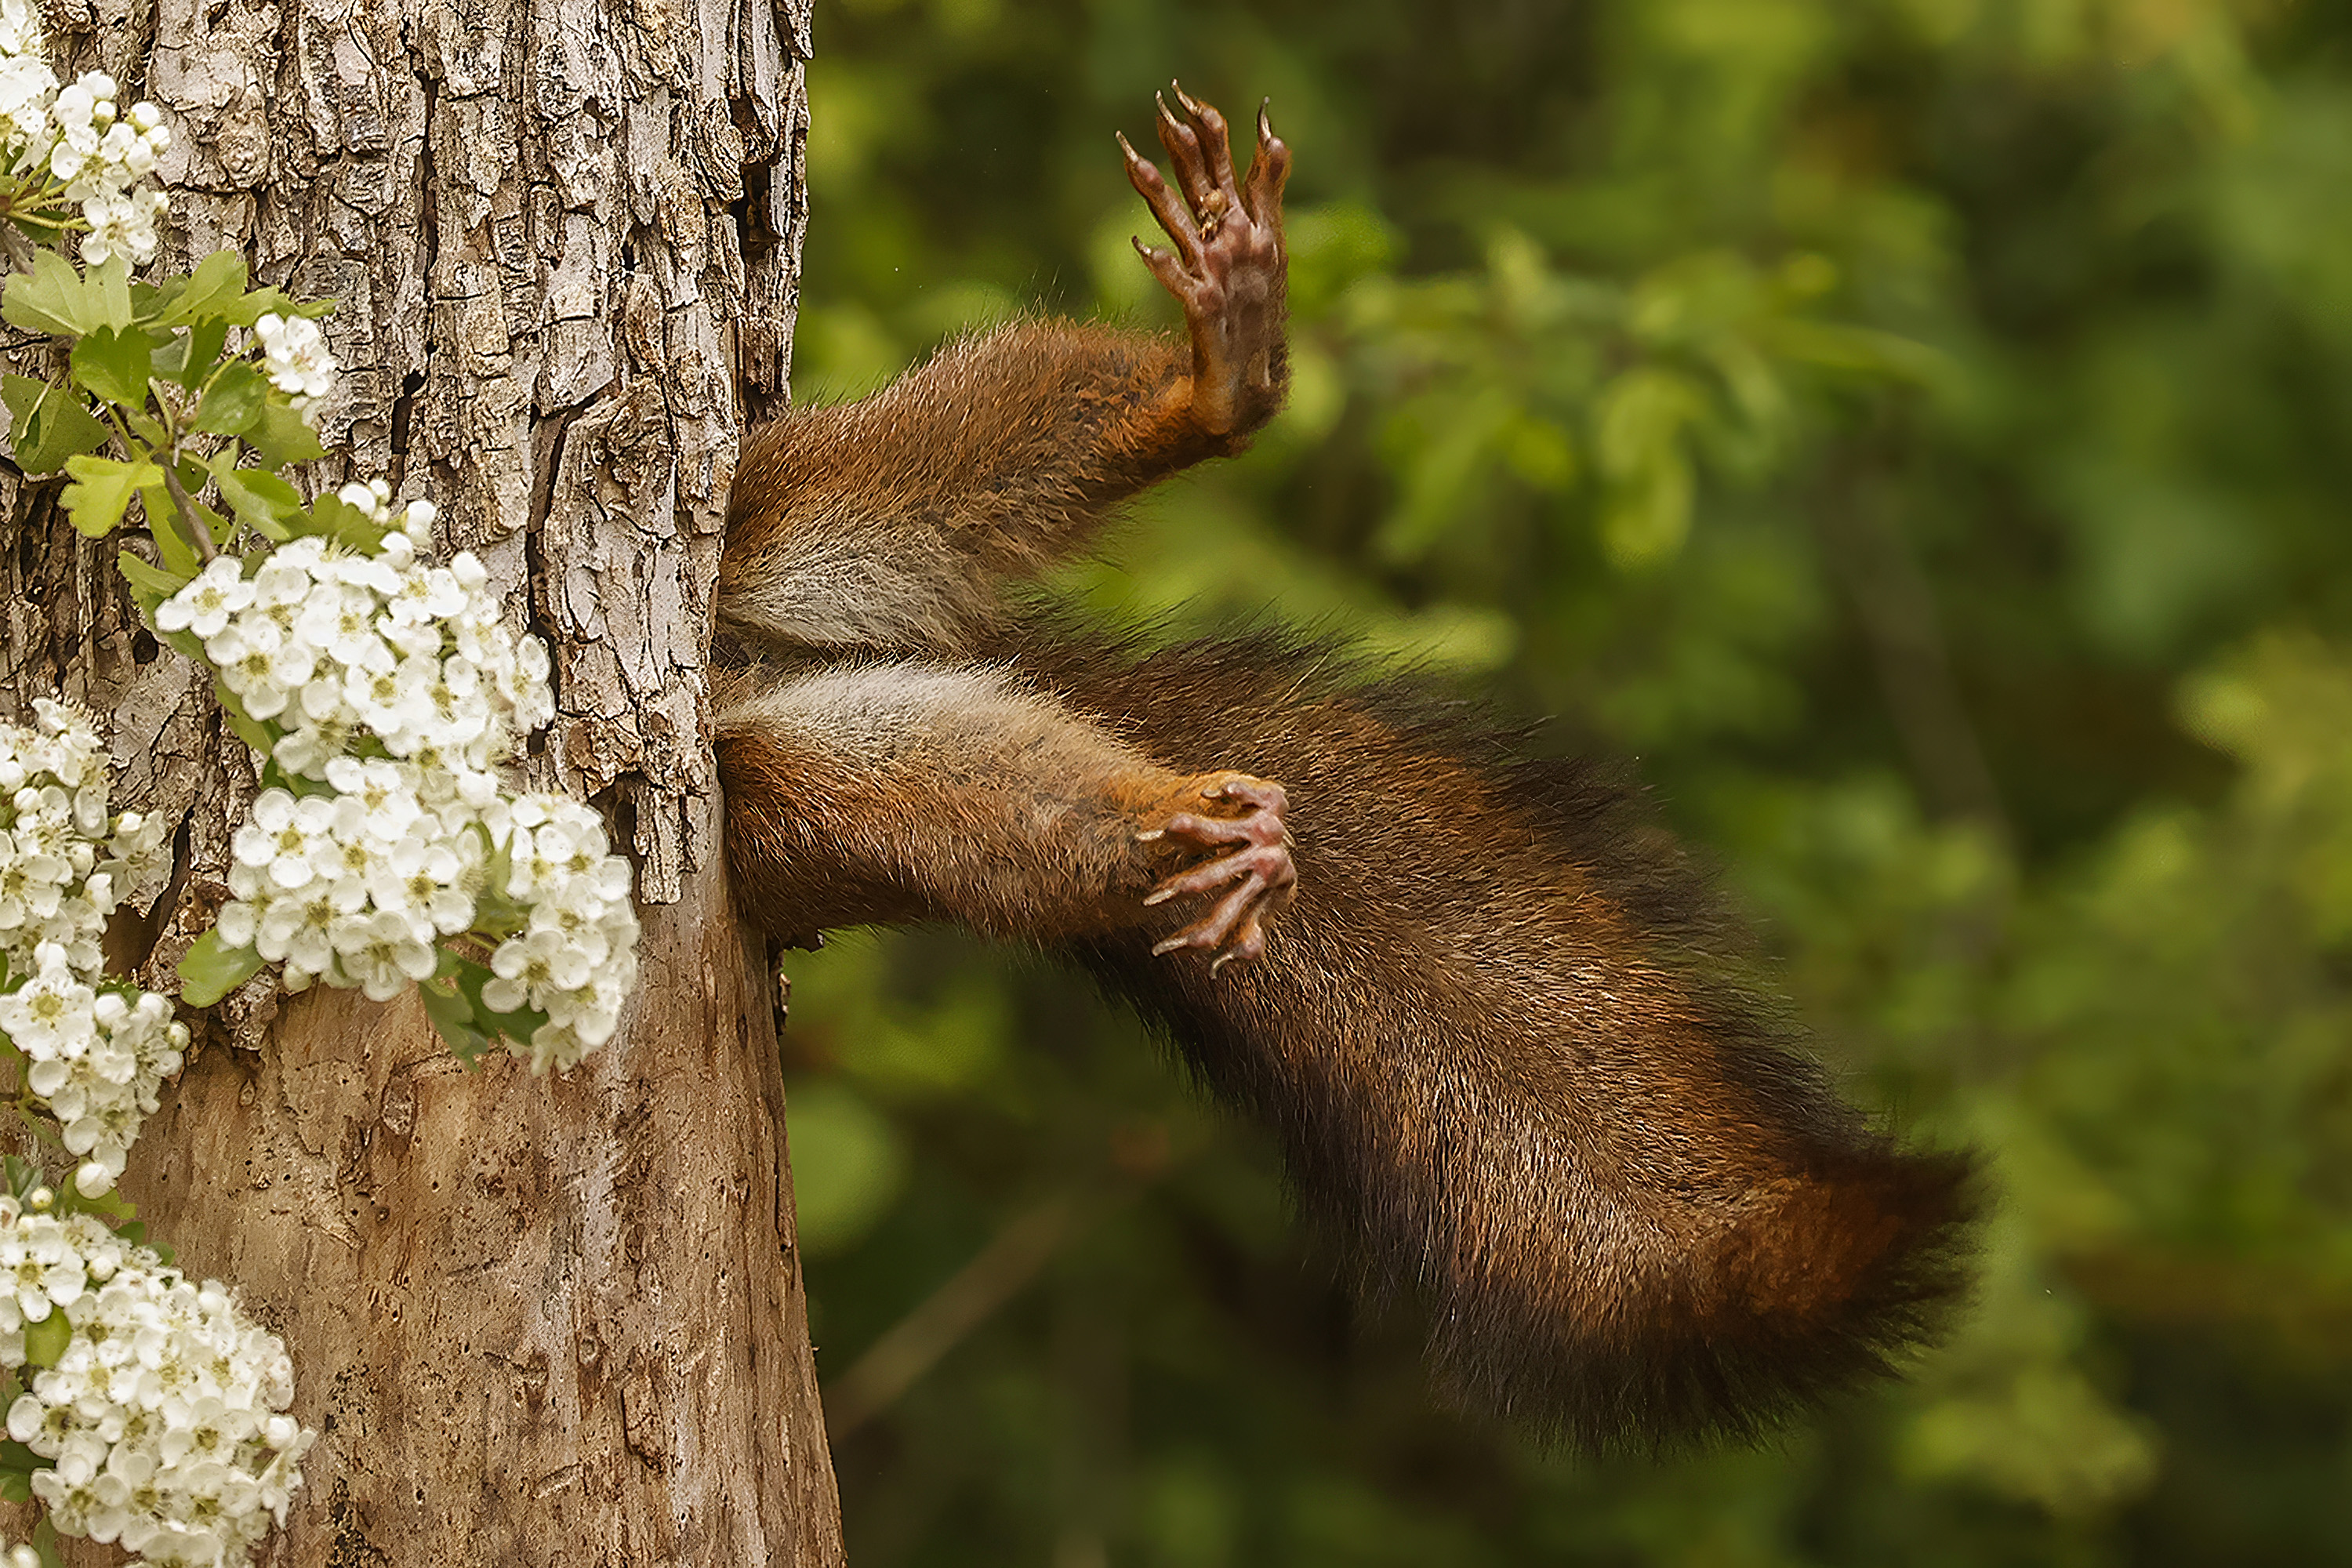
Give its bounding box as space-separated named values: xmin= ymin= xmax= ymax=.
xmin=0 ymin=0 xmax=842 ymax=1568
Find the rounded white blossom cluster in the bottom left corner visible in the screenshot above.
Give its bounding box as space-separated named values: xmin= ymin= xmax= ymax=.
xmin=0 ymin=1189 xmax=318 ymax=1568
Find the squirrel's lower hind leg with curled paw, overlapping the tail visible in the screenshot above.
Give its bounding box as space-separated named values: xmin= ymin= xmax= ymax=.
xmin=717 ymin=663 xmax=1296 ymax=973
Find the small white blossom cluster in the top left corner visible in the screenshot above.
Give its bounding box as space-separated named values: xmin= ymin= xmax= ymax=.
xmin=0 ymin=0 xmax=172 ymax=266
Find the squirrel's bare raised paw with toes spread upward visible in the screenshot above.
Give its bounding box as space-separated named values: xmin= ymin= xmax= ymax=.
xmin=1120 ymin=82 xmax=1291 ymax=440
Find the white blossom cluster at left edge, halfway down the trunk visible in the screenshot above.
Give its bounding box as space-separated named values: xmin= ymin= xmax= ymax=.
xmin=0 ymin=701 xmax=188 ymax=1196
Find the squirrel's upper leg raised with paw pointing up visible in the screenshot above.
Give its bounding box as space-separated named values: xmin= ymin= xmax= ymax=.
xmin=720 ymin=89 xmax=1289 ymax=656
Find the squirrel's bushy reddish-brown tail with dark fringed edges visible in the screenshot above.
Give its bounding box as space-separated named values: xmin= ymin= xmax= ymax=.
xmin=1025 ymin=637 xmax=1971 ymax=1448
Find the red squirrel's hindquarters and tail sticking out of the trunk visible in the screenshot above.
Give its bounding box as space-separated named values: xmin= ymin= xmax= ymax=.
xmin=715 ymin=87 xmax=1971 ymax=1448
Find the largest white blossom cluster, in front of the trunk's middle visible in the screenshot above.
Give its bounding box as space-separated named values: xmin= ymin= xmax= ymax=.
xmin=155 ymin=495 xmax=637 ymax=1067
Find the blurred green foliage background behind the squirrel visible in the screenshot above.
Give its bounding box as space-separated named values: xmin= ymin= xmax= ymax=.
xmin=786 ymin=0 xmax=2352 ymax=1568
